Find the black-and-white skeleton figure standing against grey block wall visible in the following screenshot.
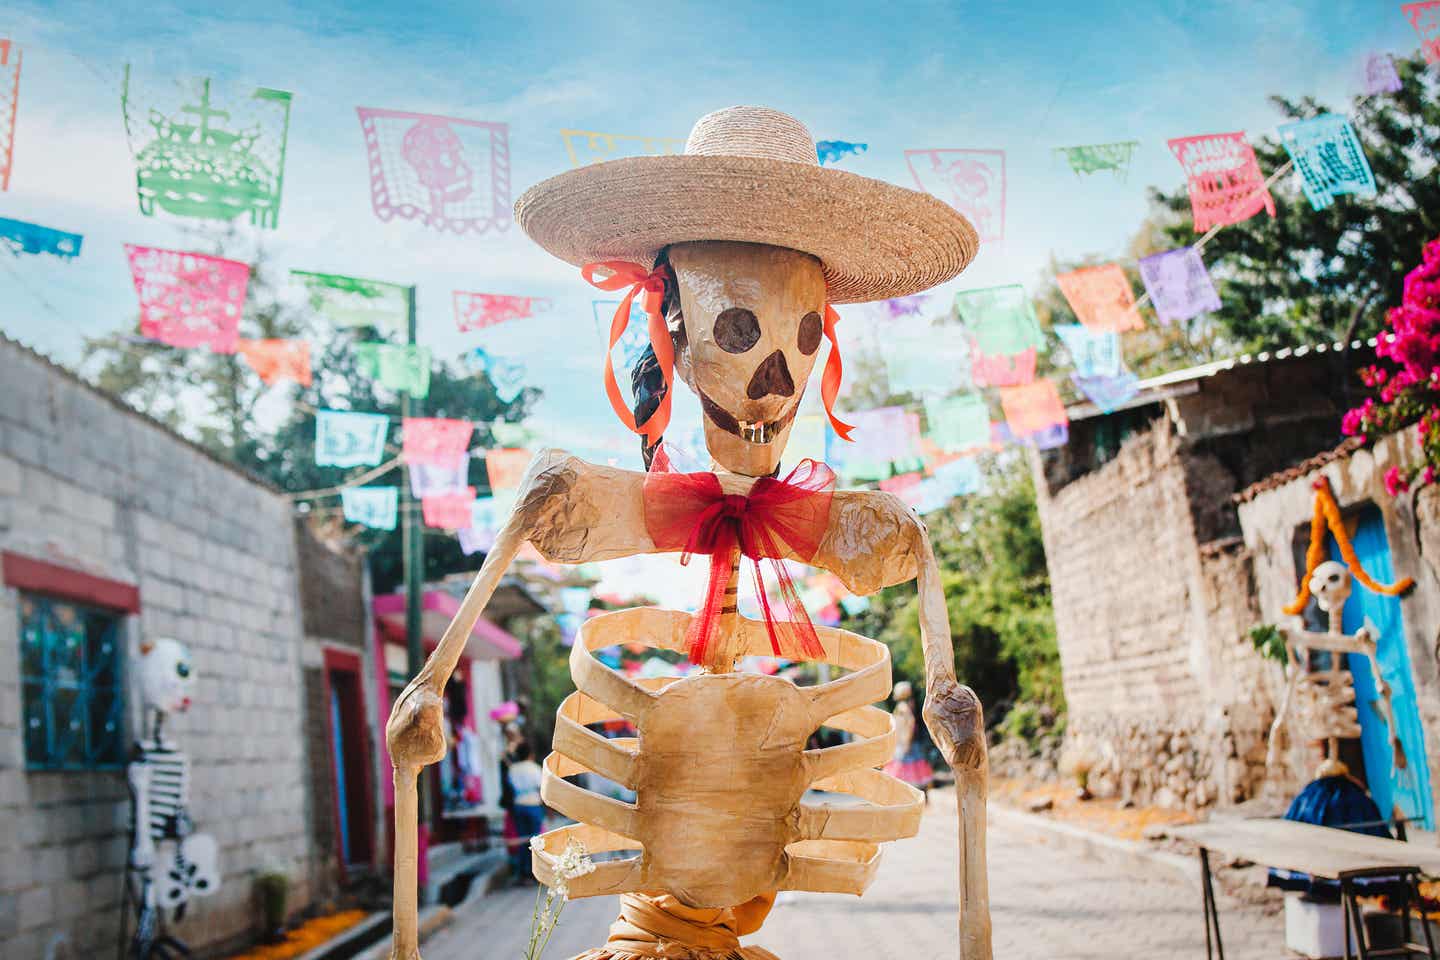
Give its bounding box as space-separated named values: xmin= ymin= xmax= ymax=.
xmin=125 ymin=638 xmax=220 ymax=959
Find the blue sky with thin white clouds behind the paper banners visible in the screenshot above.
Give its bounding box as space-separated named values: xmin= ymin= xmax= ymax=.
xmin=0 ymin=0 xmax=1417 ymax=460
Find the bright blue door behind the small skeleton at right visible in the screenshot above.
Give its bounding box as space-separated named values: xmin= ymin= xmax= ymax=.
xmin=1329 ymin=505 xmax=1434 ymax=830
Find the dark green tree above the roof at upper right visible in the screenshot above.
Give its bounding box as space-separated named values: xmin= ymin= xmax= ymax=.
xmin=1151 ymin=55 xmax=1440 ymax=350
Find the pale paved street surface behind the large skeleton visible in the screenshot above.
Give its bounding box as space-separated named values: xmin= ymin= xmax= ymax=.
xmin=423 ymin=794 xmax=1284 ymax=960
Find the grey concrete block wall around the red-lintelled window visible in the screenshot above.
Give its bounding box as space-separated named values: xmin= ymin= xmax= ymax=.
xmin=0 ymin=337 xmax=311 ymax=960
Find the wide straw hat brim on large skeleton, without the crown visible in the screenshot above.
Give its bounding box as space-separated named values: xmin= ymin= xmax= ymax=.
xmin=516 ymin=155 xmax=979 ymax=304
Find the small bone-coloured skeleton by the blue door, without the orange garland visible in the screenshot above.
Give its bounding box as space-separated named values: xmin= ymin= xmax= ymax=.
xmin=1266 ymin=560 xmax=1405 ymax=779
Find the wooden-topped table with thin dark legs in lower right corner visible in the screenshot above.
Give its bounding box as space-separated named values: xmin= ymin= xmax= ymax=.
xmin=1169 ymin=819 xmax=1440 ymax=960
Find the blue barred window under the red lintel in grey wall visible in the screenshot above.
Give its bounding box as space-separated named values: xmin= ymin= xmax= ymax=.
xmin=20 ymin=592 xmax=125 ymax=770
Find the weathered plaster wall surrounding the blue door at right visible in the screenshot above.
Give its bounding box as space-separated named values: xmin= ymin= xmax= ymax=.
xmin=1240 ymin=430 xmax=1440 ymax=810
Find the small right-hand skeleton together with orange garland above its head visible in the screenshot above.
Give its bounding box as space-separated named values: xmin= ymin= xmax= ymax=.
xmin=1266 ymin=479 xmax=1411 ymax=780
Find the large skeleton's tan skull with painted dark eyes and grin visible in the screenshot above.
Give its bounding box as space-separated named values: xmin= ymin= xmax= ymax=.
xmin=670 ymin=242 xmax=825 ymax=476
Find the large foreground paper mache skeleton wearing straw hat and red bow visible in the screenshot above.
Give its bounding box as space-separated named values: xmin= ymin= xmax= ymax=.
xmin=386 ymin=107 xmax=991 ymax=960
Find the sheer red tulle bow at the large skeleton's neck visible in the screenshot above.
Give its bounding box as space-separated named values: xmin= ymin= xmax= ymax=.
xmin=645 ymin=456 xmax=835 ymax=671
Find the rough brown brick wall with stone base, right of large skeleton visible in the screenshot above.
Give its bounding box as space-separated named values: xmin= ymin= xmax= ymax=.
xmin=1035 ymin=417 xmax=1270 ymax=807
